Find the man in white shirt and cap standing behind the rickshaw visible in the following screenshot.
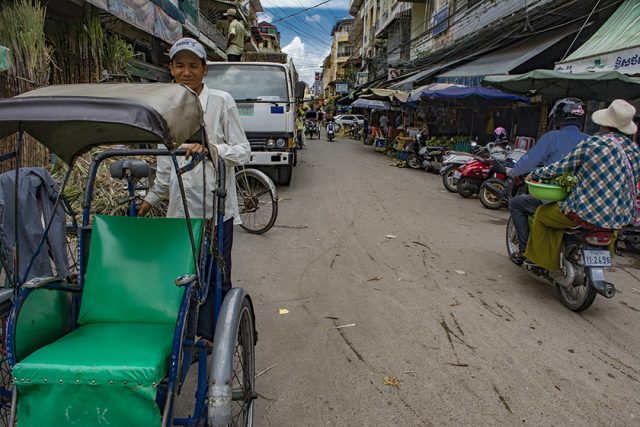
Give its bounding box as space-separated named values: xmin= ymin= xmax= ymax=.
xmin=138 ymin=38 xmax=251 ymax=341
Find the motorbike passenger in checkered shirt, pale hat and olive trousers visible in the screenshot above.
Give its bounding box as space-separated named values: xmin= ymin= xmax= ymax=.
xmin=525 ymin=99 xmax=640 ymax=270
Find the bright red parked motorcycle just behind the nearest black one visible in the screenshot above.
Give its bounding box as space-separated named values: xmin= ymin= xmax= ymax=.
xmin=453 ymin=142 xmax=508 ymax=198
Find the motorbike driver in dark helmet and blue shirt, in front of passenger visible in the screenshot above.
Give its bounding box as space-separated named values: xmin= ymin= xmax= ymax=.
xmin=508 ymin=98 xmax=589 ymax=261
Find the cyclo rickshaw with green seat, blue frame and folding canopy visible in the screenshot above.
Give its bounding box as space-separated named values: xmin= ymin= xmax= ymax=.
xmin=0 ymin=83 xmax=257 ymax=427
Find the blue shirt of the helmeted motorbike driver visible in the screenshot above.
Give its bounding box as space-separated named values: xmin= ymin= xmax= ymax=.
xmin=509 ymin=125 xmax=589 ymax=177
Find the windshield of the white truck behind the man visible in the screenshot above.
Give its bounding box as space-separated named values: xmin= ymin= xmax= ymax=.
xmin=205 ymin=64 xmax=289 ymax=102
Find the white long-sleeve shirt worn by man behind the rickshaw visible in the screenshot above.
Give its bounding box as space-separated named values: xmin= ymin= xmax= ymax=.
xmin=145 ymin=85 xmax=251 ymax=224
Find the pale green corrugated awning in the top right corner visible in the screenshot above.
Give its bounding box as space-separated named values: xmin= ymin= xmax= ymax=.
xmin=563 ymin=0 xmax=640 ymax=62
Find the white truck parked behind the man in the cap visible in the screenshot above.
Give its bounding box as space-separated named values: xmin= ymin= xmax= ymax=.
xmin=205 ymin=62 xmax=304 ymax=185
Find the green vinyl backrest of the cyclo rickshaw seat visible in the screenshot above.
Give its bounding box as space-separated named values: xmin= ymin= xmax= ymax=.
xmin=78 ymin=215 xmax=203 ymax=325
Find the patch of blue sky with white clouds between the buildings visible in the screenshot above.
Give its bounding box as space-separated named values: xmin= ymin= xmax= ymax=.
xmin=258 ymin=0 xmax=349 ymax=85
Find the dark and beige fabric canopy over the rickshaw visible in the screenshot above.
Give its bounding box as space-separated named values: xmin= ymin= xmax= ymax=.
xmin=0 ymin=83 xmax=204 ymax=164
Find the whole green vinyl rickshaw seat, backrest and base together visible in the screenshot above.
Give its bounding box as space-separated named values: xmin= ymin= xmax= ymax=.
xmin=13 ymin=216 xmax=203 ymax=427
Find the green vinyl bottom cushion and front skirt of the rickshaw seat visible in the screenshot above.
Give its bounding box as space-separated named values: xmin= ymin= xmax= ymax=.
xmin=13 ymin=323 xmax=175 ymax=427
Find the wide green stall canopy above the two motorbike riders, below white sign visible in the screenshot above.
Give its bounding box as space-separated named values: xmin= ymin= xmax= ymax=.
xmin=482 ymin=70 xmax=640 ymax=102
